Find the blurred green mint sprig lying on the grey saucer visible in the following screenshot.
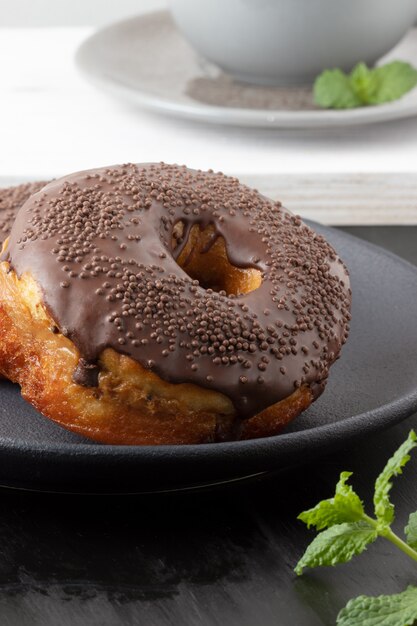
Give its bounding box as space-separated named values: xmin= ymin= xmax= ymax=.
xmin=313 ymin=61 xmax=417 ymax=109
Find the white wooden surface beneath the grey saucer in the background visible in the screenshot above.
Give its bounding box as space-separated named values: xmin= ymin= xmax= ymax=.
xmin=0 ymin=27 xmax=417 ymax=223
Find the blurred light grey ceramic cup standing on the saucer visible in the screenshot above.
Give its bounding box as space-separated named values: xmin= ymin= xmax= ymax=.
xmin=170 ymin=0 xmax=417 ymax=85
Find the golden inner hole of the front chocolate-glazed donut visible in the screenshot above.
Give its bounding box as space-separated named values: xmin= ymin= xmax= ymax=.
xmin=172 ymin=221 xmax=262 ymax=296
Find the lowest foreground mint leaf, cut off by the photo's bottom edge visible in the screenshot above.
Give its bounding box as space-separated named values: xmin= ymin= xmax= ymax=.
xmin=337 ymin=586 xmax=417 ymax=626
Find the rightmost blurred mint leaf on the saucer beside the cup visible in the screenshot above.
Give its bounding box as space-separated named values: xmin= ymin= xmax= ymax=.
xmin=369 ymin=61 xmax=417 ymax=104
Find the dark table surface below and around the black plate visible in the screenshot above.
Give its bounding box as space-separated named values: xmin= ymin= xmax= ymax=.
xmin=0 ymin=227 xmax=417 ymax=626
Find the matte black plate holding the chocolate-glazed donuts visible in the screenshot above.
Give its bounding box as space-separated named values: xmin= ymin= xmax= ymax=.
xmin=0 ymin=224 xmax=417 ymax=493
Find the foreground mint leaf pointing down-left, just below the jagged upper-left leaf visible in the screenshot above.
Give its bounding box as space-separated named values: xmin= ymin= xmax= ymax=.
xmin=295 ymin=522 xmax=378 ymax=575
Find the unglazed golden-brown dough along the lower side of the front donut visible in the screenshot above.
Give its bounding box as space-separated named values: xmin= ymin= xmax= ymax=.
xmin=0 ymin=263 xmax=312 ymax=445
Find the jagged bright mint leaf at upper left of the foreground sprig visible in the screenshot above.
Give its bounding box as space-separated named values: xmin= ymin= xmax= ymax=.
xmin=298 ymin=472 xmax=364 ymax=530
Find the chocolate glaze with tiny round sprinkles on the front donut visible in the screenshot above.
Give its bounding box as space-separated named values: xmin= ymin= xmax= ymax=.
xmin=2 ymin=163 xmax=351 ymax=418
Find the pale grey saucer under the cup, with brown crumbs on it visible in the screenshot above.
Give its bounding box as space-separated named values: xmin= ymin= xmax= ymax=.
xmin=76 ymin=11 xmax=417 ymax=128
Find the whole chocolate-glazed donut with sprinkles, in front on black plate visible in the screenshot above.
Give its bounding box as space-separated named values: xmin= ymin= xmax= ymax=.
xmin=0 ymin=163 xmax=351 ymax=445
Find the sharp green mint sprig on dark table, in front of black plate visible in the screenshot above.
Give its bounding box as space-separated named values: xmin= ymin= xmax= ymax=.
xmin=295 ymin=430 xmax=417 ymax=626
